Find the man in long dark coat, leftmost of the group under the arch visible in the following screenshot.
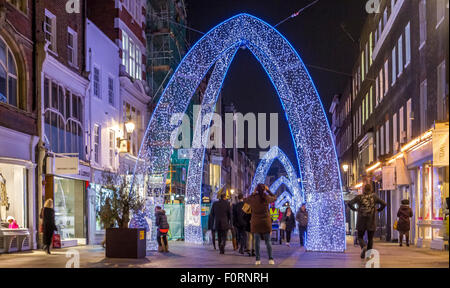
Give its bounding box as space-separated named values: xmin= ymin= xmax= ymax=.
xmin=211 ymin=193 xmax=231 ymax=254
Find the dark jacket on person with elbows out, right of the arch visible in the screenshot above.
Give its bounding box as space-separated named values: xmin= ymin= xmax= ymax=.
xmin=348 ymin=192 xmax=386 ymax=231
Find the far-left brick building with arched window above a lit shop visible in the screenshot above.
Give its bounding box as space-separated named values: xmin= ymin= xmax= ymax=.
xmin=0 ymin=0 xmax=39 ymax=253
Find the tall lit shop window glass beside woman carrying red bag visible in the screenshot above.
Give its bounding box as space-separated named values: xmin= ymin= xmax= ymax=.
xmin=54 ymin=177 xmax=86 ymax=243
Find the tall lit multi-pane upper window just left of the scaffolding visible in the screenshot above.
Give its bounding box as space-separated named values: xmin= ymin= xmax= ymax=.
xmin=122 ymin=31 xmax=142 ymax=80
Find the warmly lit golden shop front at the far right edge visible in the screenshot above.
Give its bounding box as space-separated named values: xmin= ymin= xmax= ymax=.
xmin=404 ymin=123 xmax=449 ymax=250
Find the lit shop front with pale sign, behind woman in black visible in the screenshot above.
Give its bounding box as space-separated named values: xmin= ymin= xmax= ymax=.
xmin=45 ymin=157 xmax=90 ymax=247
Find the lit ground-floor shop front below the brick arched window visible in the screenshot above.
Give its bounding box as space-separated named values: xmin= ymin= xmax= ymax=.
xmin=0 ymin=127 xmax=37 ymax=254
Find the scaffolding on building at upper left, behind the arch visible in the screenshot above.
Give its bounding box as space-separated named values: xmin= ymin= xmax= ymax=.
xmin=146 ymin=0 xmax=188 ymax=104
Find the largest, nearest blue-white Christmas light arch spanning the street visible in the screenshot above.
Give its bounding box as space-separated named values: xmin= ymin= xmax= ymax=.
xmin=132 ymin=14 xmax=345 ymax=252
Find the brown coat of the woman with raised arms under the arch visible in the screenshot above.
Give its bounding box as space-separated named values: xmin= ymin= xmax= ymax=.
xmin=244 ymin=192 xmax=277 ymax=234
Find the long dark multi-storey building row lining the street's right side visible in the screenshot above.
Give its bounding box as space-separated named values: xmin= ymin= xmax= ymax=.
xmin=330 ymin=0 xmax=449 ymax=249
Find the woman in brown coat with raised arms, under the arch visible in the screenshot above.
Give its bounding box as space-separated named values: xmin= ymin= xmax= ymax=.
xmin=244 ymin=184 xmax=277 ymax=265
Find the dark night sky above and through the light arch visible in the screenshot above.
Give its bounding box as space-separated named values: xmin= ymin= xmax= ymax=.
xmin=186 ymin=0 xmax=367 ymax=173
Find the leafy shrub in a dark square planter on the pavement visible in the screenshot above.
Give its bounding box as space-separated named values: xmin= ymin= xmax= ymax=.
xmin=97 ymin=172 xmax=146 ymax=258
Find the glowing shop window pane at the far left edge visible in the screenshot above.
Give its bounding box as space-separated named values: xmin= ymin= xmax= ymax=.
xmin=0 ymin=164 xmax=28 ymax=228
